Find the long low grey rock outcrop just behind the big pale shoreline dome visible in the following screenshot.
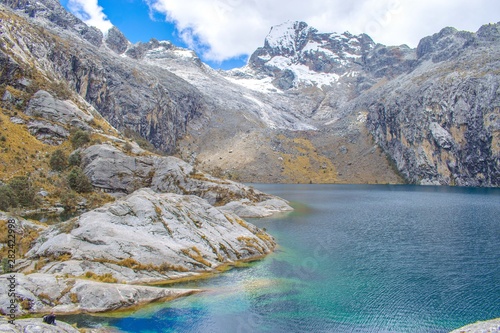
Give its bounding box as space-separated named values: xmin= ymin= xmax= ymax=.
xmin=81 ymin=145 xmax=292 ymax=217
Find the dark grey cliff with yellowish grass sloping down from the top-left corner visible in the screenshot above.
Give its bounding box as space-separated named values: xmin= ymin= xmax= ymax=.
xmin=0 ymin=0 xmax=207 ymax=152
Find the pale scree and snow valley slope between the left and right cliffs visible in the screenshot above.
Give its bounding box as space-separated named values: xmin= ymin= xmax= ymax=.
xmin=144 ymin=21 xmax=401 ymax=183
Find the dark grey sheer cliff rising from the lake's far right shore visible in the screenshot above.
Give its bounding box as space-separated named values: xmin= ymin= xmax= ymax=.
xmin=361 ymin=24 xmax=500 ymax=186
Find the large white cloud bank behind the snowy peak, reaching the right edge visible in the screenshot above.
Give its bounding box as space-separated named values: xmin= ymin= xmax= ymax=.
xmin=146 ymin=0 xmax=498 ymax=61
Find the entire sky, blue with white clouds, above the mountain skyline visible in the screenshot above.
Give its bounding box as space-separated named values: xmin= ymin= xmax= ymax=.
xmin=60 ymin=0 xmax=500 ymax=69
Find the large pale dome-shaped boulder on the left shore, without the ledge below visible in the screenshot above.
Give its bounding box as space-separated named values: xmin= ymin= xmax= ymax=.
xmin=27 ymin=189 xmax=275 ymax=283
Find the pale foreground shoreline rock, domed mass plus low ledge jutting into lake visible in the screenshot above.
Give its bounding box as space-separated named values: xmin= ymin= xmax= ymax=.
xmin=0 ymin=188 xmax=286 ymax=316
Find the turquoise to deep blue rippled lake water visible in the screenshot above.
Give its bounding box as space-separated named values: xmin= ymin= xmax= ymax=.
xmin=63 ymin=185 xmax=500 ymax=333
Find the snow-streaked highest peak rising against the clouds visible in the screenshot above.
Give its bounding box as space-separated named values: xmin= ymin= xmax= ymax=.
xmin=244 ymin=22 xmax=375 ymax=90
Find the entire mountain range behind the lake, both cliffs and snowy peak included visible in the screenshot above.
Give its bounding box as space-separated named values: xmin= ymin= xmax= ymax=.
xmin=2 ymin=0 xmax=499 ymax=186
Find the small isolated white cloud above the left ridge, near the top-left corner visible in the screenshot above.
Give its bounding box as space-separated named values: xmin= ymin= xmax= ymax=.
xmin=68 ymin=0 xmax=113 ymax=32
